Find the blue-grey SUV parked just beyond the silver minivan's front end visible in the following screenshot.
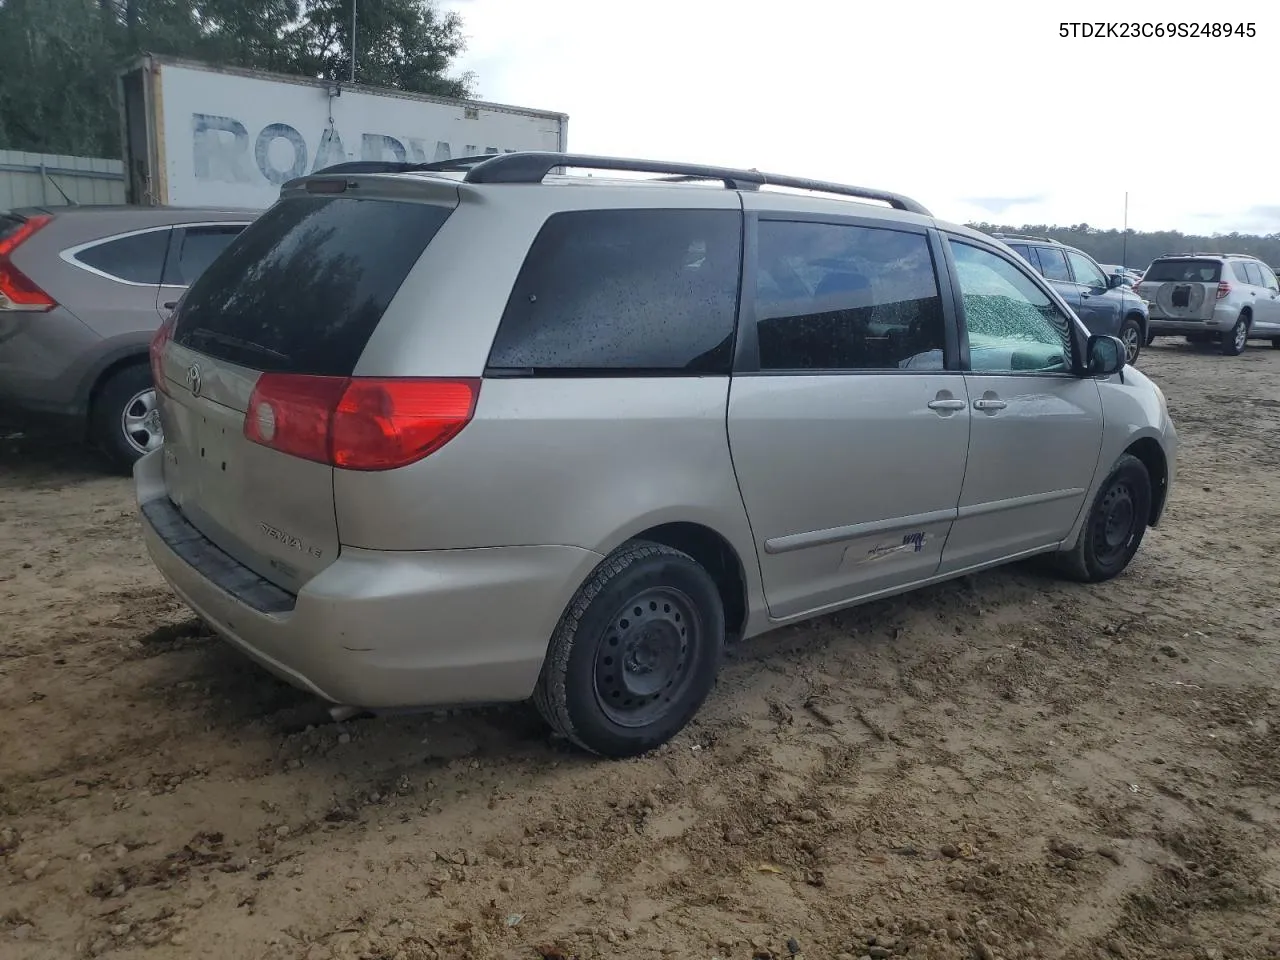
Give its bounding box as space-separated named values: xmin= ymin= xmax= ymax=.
xmin=995 ymin=233 xmax=1147 ymax=364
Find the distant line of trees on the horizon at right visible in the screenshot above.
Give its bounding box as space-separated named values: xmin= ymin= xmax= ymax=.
xmin=969 ymin=223 xmax=1280 ymax=270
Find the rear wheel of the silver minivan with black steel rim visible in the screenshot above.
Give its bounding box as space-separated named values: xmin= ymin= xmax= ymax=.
xmin=534 ymin=540 xmax=724 ymax=758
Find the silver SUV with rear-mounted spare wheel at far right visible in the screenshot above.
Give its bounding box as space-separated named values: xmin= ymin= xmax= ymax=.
xmin=1138 ymin=253 xmax=1280 ymax=357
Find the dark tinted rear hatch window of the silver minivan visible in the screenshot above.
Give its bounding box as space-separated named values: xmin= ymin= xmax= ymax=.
xmin=174 ymin=197 xmax=451 ymax=376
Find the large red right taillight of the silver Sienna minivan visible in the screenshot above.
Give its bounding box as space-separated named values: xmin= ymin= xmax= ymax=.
xmin=244 ymin=374 xmax=480 ymax=470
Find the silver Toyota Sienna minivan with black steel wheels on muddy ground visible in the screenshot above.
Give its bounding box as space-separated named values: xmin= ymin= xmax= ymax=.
xmin=134 ymin=154 xmax=1176 ymax=756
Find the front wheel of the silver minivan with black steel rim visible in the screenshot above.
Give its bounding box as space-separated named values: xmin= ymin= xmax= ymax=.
xmin=1056 ymin=453 xmax=1151 ymax=584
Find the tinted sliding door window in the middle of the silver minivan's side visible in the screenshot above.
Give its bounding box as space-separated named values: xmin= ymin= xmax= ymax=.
xmin=756 ymin=220 xmax=943 ymax=370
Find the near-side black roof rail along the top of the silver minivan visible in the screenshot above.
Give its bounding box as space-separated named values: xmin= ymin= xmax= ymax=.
xmin=460 ymin=151 xmax=933 ymax=216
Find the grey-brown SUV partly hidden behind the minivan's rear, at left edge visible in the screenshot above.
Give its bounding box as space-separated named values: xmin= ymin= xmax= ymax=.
xmin=0 ymin=206 xmax=256 ymax=470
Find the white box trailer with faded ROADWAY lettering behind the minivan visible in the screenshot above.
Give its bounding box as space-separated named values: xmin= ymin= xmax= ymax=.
xmin=119 ymin=55 xmax=568 ymax=210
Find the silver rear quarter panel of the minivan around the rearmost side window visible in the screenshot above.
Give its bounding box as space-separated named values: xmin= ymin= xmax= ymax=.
xmin=334 ymin=184 xmax=762 ymax=624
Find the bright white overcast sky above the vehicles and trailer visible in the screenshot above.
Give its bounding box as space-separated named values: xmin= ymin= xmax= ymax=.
xmin=440 ymin=0 xmax=1280 ymax=233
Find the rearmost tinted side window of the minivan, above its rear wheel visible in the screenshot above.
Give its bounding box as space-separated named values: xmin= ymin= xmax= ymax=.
xmin=489 ymin=210 xmax=742 ymax=375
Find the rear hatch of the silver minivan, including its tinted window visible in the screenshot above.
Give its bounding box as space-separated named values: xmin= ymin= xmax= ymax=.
xmin=152 ymin=189 xmax=452 ymax=593
